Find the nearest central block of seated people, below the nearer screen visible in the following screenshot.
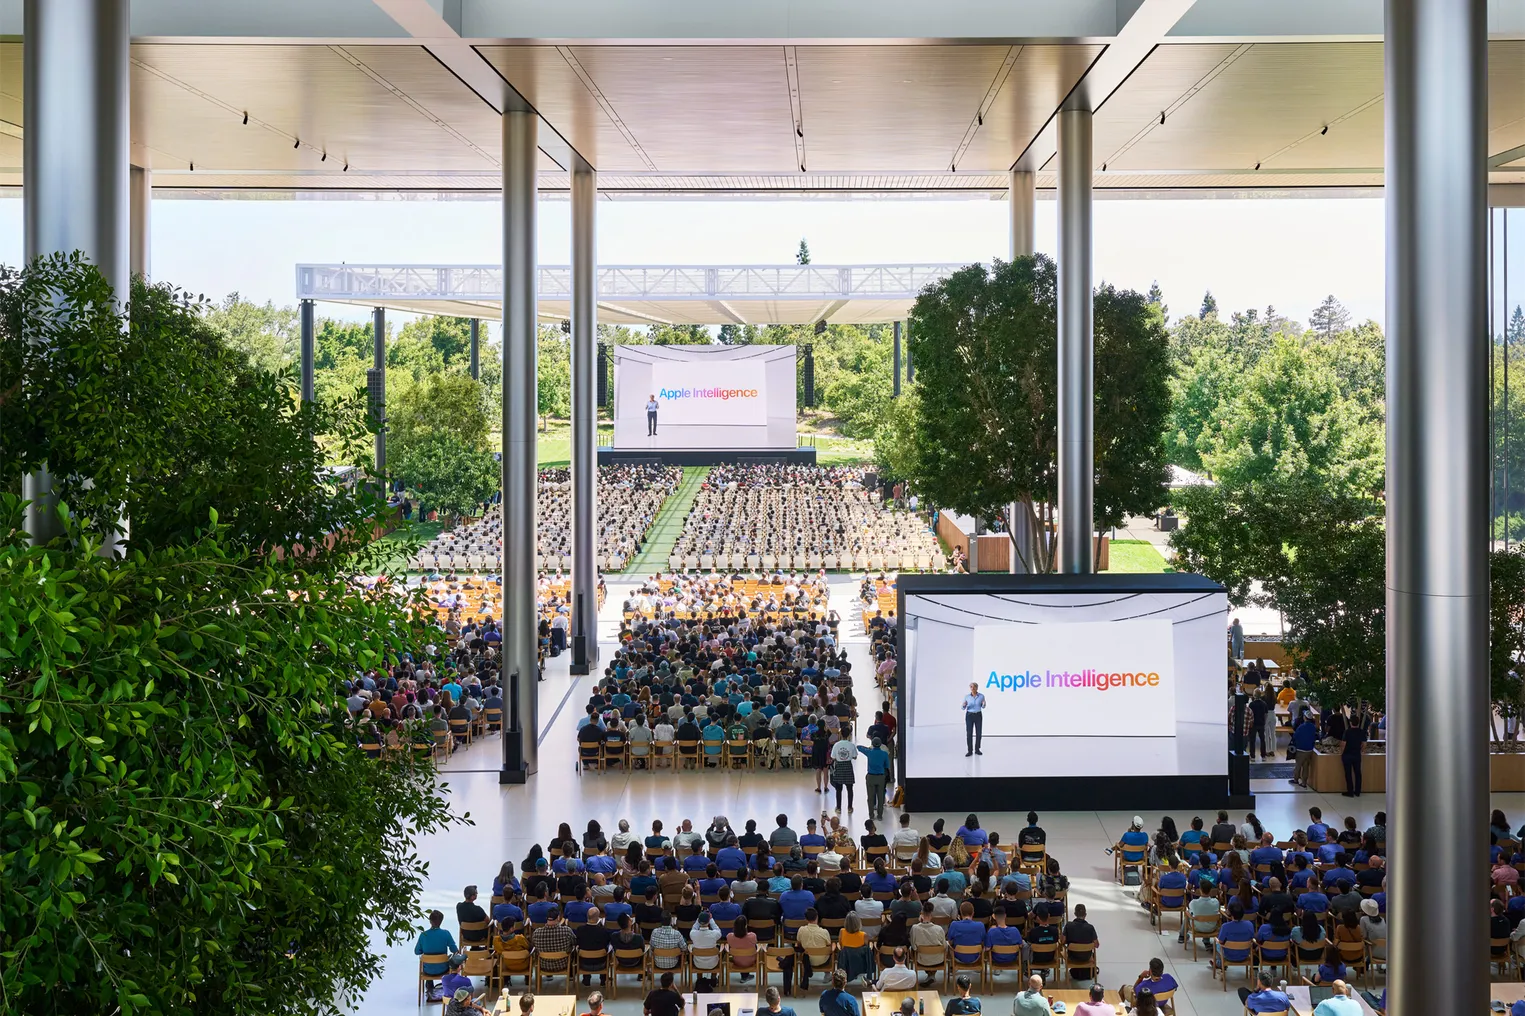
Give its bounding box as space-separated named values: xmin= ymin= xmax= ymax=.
xmin=415 ymin=815 xmax=1073 ymax=1011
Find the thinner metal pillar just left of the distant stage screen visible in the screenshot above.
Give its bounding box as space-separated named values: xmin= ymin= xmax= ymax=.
xmin=572 ymin=163 xmax=598 ymax=674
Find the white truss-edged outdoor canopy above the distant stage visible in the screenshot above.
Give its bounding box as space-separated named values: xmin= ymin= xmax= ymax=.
xmin=296 ymin=264 xmax=964 ymax=325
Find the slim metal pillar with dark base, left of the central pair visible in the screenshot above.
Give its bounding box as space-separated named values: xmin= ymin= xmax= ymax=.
xmin=499 ymin=110 xmax=540 ymax=783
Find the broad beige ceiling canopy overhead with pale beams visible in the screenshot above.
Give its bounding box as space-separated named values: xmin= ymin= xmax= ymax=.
xmin=0 ymin=0 xmax=1525 ymax=198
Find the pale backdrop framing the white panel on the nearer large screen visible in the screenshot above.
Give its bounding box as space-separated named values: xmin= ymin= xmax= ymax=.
xmin=901 ymin=590 xmax=1228 ymax=778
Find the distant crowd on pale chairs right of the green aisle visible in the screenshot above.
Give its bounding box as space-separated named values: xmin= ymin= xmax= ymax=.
xmin=669 ymin=465 xmax=946 ymax=572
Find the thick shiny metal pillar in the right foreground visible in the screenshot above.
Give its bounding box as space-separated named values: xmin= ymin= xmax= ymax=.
xmin=1385 ymin=0 xmax=1488 ymax=1016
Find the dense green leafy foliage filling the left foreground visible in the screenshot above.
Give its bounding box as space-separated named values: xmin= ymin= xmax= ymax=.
xmin=0 ymin=259 xmax=459 ymax=1016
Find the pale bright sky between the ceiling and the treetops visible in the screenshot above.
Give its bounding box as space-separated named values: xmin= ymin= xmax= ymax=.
xmin=0 ymin=192 xmax=1383 ymax=332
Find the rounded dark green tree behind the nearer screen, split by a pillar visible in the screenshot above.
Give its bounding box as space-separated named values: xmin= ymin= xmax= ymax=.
xmin=881 ymin=255 xmax=1170 ymax=572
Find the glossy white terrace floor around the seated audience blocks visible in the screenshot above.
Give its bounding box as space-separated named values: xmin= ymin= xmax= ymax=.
xmin=351 ymin=577 xmax=1464 ymax=1016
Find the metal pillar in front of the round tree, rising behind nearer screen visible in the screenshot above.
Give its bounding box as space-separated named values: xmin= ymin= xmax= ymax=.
xmin=1058 ymin=110 xmax=1095 ymax=575
